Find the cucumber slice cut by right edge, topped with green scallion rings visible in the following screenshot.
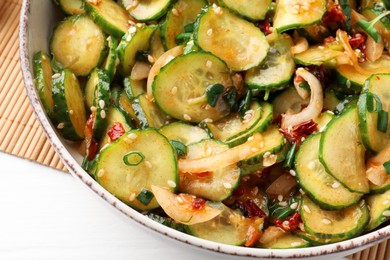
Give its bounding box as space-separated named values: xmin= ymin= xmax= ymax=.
xmin=358 ymin=74 xmax=390 ymax=153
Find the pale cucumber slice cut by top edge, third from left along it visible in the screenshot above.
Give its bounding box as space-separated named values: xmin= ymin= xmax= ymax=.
xmin=121 ymin=0 xmax=172 ymax=22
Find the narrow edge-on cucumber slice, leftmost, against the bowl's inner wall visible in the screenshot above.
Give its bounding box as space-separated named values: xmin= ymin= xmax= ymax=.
xmin=33 ymin=51 xmax=54 ymax=116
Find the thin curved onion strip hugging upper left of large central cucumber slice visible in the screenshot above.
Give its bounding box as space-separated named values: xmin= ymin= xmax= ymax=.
xmin=146 ymin=45 xmax=184 ymax=101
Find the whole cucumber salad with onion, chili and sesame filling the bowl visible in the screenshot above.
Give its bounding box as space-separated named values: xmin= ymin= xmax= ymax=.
xmin=33 ymin=0 xmax=390 ymax=248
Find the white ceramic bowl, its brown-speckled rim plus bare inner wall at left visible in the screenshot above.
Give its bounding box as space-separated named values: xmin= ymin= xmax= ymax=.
xmin=20 ymin=0 xmax=390 ymax=259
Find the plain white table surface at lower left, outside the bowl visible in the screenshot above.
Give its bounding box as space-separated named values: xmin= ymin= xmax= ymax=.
xmin=0 ymin=152 xmax=352 ymax=260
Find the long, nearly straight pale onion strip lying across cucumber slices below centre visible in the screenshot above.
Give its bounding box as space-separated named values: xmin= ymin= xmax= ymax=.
xmin=179 ymin=133 xmax=263 ymax=173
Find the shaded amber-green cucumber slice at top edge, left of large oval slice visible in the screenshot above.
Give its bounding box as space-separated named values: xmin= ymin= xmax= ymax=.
xmin=161 ymin=0 xmax=207 ymax=50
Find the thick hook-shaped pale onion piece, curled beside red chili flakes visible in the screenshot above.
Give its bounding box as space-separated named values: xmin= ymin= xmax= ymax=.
xmin=281 ymin=68 xmax=324 ymax=129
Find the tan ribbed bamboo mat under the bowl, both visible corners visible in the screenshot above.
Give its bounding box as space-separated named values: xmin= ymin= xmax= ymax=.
xmin=0 ymin=0 xmax=390 ymax=260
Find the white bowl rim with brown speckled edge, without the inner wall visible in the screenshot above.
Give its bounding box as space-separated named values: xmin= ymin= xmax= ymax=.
xmin=19 ymin=0 xmax=390 ymax=258
